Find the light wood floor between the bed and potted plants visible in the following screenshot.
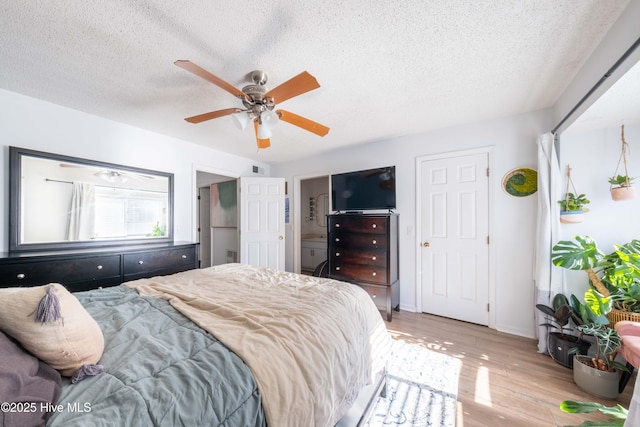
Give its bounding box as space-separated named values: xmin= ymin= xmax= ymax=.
xmin=387 ymin=311 xmax=636 ymax=427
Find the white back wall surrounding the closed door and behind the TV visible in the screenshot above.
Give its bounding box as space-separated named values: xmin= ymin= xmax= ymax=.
xmin=272 ymin=110 xmax=551 ymax=337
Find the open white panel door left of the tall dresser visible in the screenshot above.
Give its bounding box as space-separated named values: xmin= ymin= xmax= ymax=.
xmin=238 ymin=177 xmax=285 ymax=270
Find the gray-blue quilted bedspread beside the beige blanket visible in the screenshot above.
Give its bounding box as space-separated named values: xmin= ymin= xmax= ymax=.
xmin=47 ymin=285 xmax=265 ymax=427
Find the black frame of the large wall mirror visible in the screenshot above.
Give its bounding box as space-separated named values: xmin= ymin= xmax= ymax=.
xmin=9 ymin=147 xmax=174 ymax=252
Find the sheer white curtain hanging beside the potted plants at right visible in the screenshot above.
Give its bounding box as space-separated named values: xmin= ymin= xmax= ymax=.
xmin=534 ymin=133 xmax=562 ymax=353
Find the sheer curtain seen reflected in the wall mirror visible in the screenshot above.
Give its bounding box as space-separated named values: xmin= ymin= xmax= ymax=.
xmin=67 ymin=182 xmax=95 ymax=240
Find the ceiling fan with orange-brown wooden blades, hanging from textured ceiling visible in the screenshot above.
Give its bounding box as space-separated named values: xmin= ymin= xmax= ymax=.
xmin=174 ymin=60 xmax=329 ymax=148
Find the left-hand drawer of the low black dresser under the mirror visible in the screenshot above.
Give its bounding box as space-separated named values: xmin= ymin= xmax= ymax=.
xmin=1 ymin=255 xmax=120 ymax=287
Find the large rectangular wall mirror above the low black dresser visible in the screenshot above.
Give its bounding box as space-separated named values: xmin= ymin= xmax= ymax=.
xmin=9 ymin=147 xmax=173 ymax=251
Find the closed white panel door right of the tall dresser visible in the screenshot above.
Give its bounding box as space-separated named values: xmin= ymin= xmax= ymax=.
xmin=419 ymin=153 xmax=489 ymax=325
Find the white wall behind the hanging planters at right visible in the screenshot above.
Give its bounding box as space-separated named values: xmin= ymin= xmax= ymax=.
xmin=559 ymin=124 xmax=640 ymax=300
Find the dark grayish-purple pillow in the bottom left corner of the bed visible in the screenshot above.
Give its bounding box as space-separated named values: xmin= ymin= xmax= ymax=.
xmin=0 ymin=332 xmax=62 ymax=427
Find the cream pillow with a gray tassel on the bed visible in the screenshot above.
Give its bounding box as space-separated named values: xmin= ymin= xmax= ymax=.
xmin=0 ymin=283 xmax=104 ymax=377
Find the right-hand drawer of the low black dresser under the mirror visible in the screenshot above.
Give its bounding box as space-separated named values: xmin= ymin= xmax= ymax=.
xmin=124 ymin=246 xmax=196 ymax=280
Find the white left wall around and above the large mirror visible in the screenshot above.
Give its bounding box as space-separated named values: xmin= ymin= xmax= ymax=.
xmin=0 ymin=90 xmax=270 ymax=252
